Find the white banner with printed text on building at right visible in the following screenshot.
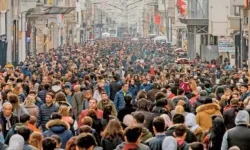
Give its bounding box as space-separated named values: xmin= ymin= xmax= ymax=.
xmin=218 ymin=37 xmax=235 ymax=53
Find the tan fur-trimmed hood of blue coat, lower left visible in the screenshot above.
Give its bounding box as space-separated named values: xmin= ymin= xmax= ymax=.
xmin=46 ymin=119 xmax=70 ymax=133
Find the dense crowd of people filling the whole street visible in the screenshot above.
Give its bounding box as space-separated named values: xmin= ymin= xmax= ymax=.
xmin=0 ymin=38 xmax=250 ymax=150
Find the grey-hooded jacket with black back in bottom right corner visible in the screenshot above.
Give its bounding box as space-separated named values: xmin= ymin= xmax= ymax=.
xmin=221 ymin=110 xmax=250 ymax=150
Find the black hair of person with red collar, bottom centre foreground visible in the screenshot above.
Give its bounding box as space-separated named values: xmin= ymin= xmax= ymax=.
xmin=124 ymin=126 xmax=142 ymax=143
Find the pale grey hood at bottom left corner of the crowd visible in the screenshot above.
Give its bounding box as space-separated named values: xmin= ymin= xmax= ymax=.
xmin=8 ymin=134 xmax=24 ymax=150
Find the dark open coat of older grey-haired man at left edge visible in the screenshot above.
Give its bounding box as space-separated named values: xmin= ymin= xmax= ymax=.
xmin=0 ymin=112 xmax=19 ymax=137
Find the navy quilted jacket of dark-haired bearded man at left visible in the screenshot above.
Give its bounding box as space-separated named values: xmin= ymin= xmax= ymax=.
xmin=36 ymin=104 xmax=59 ymax=131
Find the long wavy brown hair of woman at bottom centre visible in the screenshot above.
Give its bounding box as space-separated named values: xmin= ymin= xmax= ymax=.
xmin=102 ymin=119 xmax=123 ymax=138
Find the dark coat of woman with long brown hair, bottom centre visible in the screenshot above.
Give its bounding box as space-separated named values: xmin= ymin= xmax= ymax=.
xmin=101 ymin=135 xmax=123 ymax=150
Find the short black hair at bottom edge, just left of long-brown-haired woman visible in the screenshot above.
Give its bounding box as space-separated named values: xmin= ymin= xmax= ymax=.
xmin=76 ymin=133 xmax=97 ymax=149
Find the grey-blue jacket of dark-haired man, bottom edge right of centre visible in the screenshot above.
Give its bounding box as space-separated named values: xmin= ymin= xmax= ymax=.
xmin=145 ymin=133 xmax=166 ymax=150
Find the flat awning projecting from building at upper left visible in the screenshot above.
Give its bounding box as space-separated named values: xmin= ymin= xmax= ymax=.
xmin=26 ymin=6 xmax=75 ymax=18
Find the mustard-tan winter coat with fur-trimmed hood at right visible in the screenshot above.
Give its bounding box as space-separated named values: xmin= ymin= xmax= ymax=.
xmin=196 ymin=103 xmax=222 ymax=132
